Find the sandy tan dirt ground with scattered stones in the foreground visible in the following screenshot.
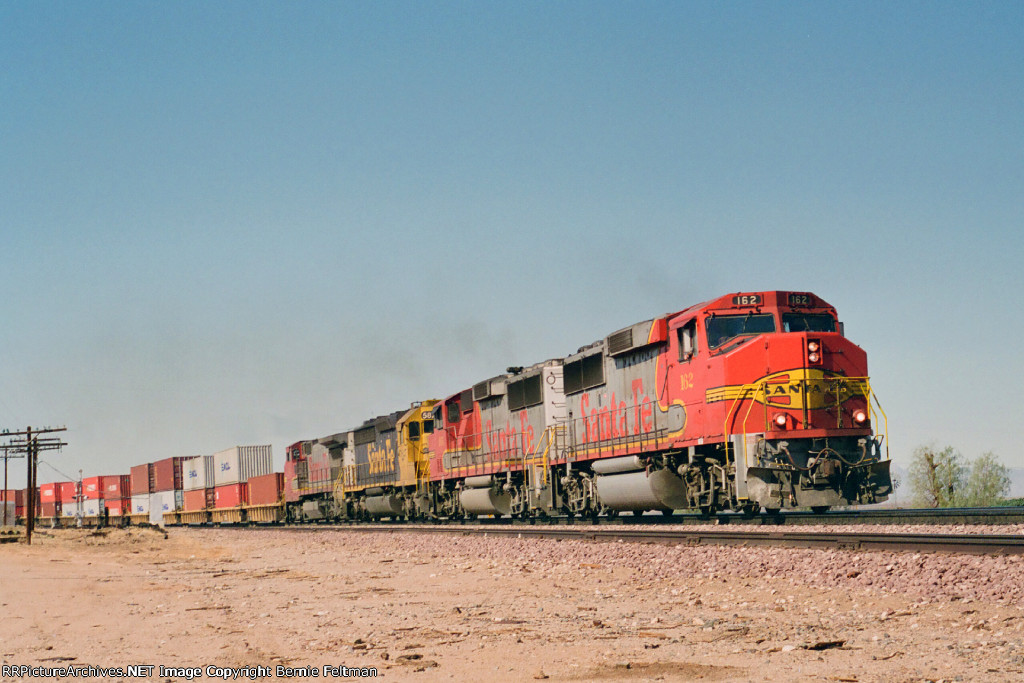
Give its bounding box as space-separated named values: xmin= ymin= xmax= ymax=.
xmin=0 ymin=529 xmax=1024 ymax=683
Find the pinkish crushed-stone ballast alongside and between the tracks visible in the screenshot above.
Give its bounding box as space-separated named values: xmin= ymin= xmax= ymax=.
xmin=385 ymin=525 xmax=1024 ymax=607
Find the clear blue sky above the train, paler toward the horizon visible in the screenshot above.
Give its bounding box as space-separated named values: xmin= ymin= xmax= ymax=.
xmin=0 ymin=1 xmax=1024 ymax=480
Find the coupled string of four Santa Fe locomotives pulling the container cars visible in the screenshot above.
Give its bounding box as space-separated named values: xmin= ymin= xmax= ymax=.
xmin=285 ymin=291 xmax=892 ymax=521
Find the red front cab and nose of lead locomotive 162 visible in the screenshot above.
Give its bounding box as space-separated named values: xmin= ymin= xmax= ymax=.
xmin=705 ymin=292 xmax=892 ymax=509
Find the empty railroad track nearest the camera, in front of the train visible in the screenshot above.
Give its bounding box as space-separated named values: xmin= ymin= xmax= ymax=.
xmin=268 ymin=524 xmax=1024 ymax=555
